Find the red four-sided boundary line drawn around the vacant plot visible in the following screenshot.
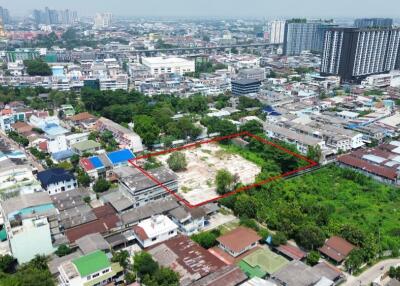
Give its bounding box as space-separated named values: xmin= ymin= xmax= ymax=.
xmin=129 ymin=131 xmax=318 ymax=208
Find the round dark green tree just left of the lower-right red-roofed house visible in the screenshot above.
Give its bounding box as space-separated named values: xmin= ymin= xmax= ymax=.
xmin=295 ymin=225 xmax=325 ymax=250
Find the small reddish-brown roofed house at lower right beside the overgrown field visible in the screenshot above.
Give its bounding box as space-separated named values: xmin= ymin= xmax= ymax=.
xmin=318 ymin=236 xmax=356 ymax=264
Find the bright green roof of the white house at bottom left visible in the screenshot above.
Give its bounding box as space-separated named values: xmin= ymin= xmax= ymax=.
xmin=72 ymin=250 xmax=111 ymax=277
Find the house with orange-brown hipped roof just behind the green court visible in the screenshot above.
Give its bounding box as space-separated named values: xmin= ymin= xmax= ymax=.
xmin=217 ymin=226 xmax=261 ymax=257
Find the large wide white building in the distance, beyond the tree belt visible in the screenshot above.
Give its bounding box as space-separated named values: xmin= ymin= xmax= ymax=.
xmin=142 ymin=57 xmax=196 ymax=75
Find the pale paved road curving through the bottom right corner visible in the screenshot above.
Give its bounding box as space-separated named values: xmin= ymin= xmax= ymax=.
xmin=343 ymin=259 xmax=400 ymax=286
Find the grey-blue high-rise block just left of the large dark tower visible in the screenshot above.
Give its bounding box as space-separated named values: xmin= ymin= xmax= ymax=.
xmin=283 ymin=19 xmax=332 ymax=56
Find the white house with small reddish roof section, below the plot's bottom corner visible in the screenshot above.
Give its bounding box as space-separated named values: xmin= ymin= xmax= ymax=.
xmin=133 ymin=215 xmax=178 ymax=248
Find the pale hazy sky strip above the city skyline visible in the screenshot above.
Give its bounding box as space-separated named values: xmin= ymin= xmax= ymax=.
xmin=0 ymin=0 xmax=400 ymax=18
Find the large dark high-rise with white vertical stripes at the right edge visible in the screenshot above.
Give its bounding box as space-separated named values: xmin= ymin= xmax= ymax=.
xmin=321 ymin=28 xmax=400 ymax=82
